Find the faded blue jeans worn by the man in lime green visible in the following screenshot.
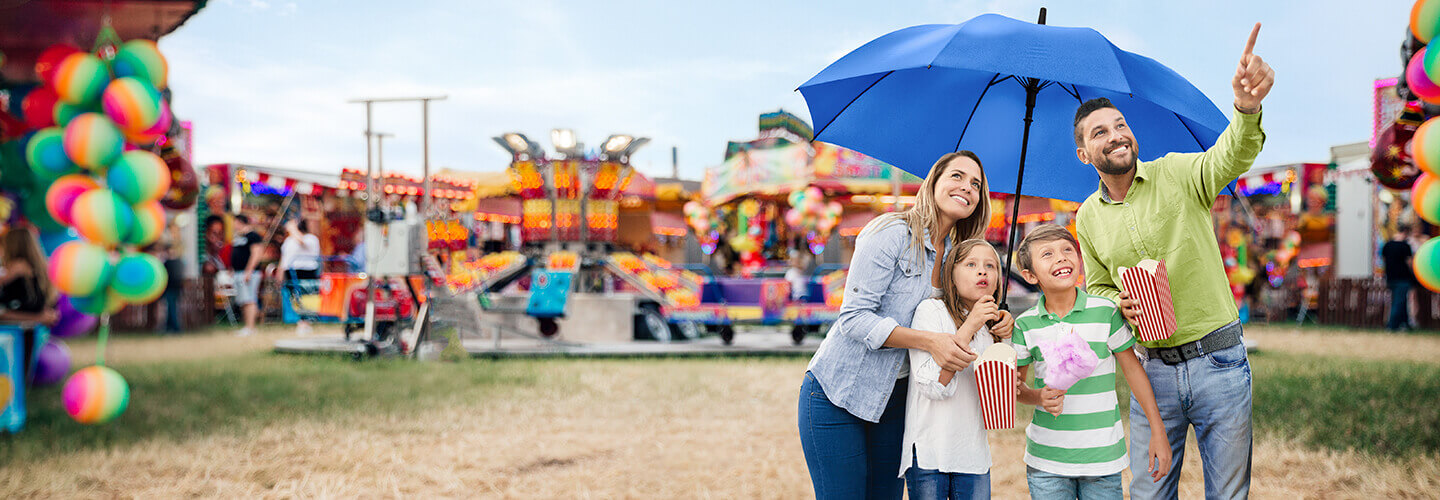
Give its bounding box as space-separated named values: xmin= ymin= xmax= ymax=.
xmin=1130 ymin=338 xmax=1254 ymax=499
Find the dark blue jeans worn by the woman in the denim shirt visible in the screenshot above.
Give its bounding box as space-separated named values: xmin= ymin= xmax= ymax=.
xmin=799 ymin=372 xmax=909 ymax=500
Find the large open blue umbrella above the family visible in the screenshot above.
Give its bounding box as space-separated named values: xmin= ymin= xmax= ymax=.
xmin=799 ymin=9 xmax=1228 ymax=301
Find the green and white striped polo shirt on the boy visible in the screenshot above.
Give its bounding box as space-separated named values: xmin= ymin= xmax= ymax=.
xmin=1014 ymin=290 xmax=1135 ymax=476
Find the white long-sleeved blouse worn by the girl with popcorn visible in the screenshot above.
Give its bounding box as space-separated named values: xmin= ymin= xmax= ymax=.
xmin=900 ymin=298 xmax=995 ymax=477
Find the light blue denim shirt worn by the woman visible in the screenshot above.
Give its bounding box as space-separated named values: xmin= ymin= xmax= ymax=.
xmin=809 ymin=220 xmax=936 ymax=422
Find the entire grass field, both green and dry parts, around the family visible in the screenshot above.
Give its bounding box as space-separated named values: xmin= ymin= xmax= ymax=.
xmin=0 ymin=329 xmax=1440 ymax=499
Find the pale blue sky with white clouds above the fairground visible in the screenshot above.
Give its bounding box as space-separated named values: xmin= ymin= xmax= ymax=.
xmin=160 ymin=0 xmax=1411 ymax=179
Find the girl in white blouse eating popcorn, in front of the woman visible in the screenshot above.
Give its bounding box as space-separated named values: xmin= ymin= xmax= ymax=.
xmin=900 ymin=239 xmax=1001 ymax=500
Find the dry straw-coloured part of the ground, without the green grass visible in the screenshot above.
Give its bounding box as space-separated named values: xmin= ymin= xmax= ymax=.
xmin=0 ymin=329 xmax=1440 ymax=499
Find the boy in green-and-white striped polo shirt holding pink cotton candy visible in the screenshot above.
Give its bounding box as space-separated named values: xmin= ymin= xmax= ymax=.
xmin=1014 ymin=223 xmax=1171 ymax=499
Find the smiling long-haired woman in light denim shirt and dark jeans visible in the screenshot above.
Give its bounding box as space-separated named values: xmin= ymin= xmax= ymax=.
xmin=799 ymin=151 xmax=1015 ymax=499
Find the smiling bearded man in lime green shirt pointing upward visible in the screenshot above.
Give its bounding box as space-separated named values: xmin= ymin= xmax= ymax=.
xmin=1076 ymin=23 xmax=1274 ymax=499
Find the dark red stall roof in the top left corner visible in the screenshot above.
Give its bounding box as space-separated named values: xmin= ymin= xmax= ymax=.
xmin=0 ymin=0 xmax=206 ymax=82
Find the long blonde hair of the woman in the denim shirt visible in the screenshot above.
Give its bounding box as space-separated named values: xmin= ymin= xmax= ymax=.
xmin=860 ymin=150 xmax=989 ymax=264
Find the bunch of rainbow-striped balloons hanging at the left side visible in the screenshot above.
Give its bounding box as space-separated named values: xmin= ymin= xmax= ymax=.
xmin=23 ymin=40 xmax=173 ymax=424
